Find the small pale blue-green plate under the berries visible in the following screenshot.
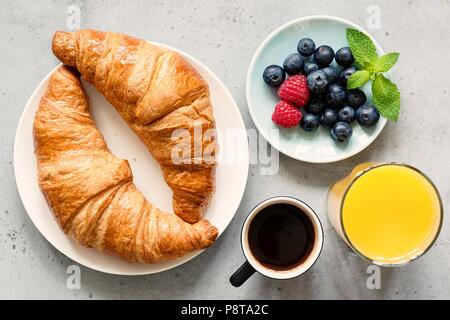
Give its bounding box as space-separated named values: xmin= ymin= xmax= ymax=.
xmin=246 ymin=16 xmax=386 ymax=163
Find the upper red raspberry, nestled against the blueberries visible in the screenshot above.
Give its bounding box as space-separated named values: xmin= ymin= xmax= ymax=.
xmin=278 ymin=75 xmax=310 ymax=107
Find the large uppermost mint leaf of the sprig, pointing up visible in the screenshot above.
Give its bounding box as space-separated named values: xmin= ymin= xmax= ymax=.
xmin=346 ymin=29 xmax=378 ymax=69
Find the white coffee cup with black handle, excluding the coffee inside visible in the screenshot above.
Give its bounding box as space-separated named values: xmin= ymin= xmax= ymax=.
xmin=230 ymin=196 xmax=323 ymax=287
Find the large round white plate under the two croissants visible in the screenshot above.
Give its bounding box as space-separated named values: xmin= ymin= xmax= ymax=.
xmin=14 ymin=43 xmax=249 ymax=275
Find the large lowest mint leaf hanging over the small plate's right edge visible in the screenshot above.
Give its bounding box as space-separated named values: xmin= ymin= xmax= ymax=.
xmin=372 ymin=73 xmax=400 ymax=121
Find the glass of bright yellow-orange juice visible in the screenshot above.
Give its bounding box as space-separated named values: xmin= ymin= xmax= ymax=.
xmin=327 ymin=162 xmax=443 ymax=267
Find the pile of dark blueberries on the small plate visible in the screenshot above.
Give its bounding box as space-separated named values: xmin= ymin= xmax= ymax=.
xmin=263 ymin=38 xmax=380 ymax=142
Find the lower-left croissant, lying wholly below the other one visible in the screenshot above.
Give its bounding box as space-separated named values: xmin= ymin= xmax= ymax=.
xmin=33 ymin=66 xmax=217 ymax=263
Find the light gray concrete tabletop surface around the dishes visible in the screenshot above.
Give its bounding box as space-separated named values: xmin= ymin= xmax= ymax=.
xmin=0 ymin=0 xmax=450 ymax=299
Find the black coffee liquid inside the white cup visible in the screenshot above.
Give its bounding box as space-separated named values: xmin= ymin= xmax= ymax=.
xmin=248 ymin=204 xmax=315 ymax=270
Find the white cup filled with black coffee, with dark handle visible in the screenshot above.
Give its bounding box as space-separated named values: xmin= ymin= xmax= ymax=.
xmin=230 ymin=197 xmax=323 ymax=287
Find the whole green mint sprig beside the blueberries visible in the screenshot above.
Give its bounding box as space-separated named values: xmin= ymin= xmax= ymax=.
xmin=346 ymin=29 xmax=400 ymax=121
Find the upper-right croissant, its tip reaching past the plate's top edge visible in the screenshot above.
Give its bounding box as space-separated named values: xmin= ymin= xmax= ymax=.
xmin=52 ymin=30 xmax=217 ymax=223
